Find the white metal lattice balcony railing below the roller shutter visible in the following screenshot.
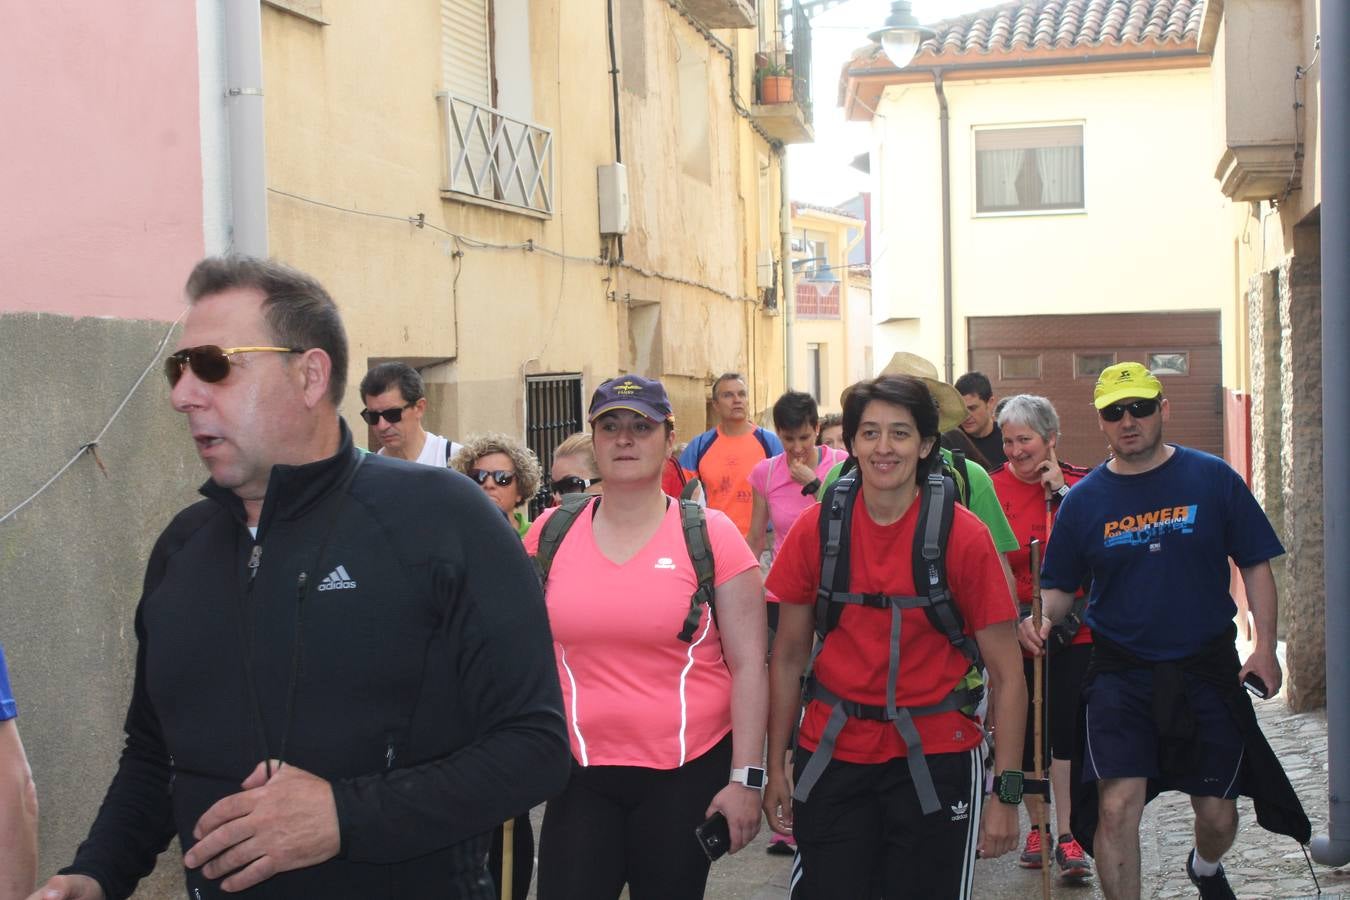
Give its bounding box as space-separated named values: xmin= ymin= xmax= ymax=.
xmin=436 ymin=92 xmax=554 ymax=216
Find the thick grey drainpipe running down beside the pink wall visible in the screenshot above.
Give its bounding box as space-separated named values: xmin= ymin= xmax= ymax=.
xmin=221 ymin=0 xmax=267 ymax=256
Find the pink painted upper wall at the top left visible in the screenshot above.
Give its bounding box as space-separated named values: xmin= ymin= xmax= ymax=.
xmin=0 ymin=0 xmax=204 ymax=320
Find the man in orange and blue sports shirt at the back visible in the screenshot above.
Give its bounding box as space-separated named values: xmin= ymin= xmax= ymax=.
xmin=679 ymin=372 xmax=783 ymax=537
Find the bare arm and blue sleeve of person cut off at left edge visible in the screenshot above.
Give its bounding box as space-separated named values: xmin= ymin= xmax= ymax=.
xmin=0 ymin=646 xmax=38 ymax=900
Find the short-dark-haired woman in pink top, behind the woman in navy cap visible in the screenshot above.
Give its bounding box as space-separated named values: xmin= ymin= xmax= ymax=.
xmin=745 ymin=391 xmax=848 ymax=559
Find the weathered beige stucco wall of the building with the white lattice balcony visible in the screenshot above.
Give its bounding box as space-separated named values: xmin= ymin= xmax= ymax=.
xmin=263 ymin=0 xmax=783 ymax=437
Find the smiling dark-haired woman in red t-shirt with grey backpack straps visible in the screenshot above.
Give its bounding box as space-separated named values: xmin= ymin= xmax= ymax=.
xmin=764 ymin=375 xmax=1026 ymax=900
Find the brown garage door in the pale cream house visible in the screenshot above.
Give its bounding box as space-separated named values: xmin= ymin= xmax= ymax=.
xmin=967 ymin=312 xmax=1223 ymax=466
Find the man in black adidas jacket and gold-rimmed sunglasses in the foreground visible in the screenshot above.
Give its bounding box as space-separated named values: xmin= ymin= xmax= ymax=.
xmin=34 ymin=258 xmax=570 ymax=900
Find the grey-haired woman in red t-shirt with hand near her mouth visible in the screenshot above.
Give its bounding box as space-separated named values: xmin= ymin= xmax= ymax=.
xmin=990 ymin=394 xmax=1092 ymax=880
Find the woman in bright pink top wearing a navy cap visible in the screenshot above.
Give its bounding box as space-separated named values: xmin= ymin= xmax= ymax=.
xmin=525 ymin=375 xmax=768 ymax=900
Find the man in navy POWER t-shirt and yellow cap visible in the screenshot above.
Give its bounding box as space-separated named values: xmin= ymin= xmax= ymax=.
xmin=1021 ymin=363 xmax=1311 ymax=900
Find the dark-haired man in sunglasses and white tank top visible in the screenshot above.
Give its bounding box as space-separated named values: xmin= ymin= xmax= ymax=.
xmin=360 ymin=363 xmax=459 ymax=468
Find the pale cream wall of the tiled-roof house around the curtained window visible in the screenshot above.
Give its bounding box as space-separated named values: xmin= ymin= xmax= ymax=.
xmin=872 ymin=69 xmax=1237 ymax=378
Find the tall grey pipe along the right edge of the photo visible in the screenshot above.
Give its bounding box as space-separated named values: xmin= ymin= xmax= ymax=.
xmin=1312 ymin=3 xmax=1350 ymax=866
